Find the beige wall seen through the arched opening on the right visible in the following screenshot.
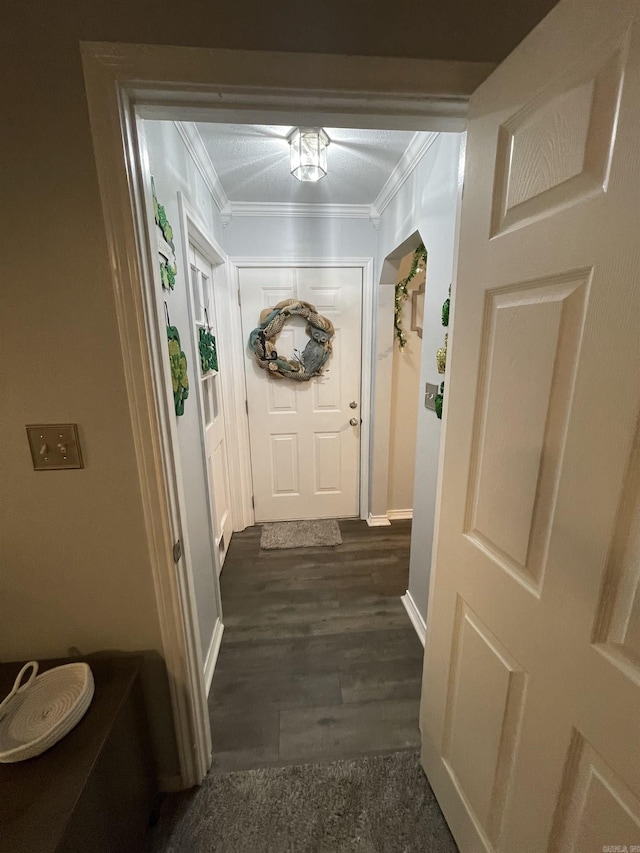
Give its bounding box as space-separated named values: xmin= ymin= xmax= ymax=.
xmin=387 ymin=252 xmax=424 ymax=511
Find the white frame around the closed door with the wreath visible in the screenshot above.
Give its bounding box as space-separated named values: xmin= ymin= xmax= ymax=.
xmin=229 ymin=256 xmax=376 ymax=524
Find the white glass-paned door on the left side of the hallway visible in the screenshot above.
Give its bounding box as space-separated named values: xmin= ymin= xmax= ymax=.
xmin=189 ymin=245 xmax=233 ymax=573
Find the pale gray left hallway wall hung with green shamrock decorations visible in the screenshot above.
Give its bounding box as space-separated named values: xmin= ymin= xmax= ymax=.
xmin=144 ymin=121 xmax=222 ymax=663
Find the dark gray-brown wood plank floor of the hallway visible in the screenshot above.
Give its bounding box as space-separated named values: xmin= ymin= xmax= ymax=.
xmin=209 ymin=520 xmax=423 ymax=770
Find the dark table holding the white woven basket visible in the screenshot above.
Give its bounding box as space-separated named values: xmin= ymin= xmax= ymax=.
xmin=0 ymin=656 xmax=157 ymax=853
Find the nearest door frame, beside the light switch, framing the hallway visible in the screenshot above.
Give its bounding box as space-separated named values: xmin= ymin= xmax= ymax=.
xmin=81 ymin=42 xmax=480 ymax=787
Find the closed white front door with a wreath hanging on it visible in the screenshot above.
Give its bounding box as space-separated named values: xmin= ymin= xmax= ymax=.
xmin=239 ymin=267 xmax=362 ymax=522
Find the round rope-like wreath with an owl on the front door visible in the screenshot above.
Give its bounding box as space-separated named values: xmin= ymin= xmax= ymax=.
xmin=249 ymin=299 xmax=335 ymax=382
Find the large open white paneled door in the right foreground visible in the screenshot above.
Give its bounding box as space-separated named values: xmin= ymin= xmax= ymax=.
xmin=421 ymin=0 xmax=640 ymax=853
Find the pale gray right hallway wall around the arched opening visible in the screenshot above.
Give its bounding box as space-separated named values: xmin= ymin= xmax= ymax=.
xmin=374 ymin=133 xmax=462 ymax=620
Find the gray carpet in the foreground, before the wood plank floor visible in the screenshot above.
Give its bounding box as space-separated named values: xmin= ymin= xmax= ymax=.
xmin=153 ymin=752 xmax=458 ymax=853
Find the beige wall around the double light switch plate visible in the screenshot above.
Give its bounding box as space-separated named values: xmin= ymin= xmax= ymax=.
xmin=0 ymin=0 xmax=553 ymax=772
